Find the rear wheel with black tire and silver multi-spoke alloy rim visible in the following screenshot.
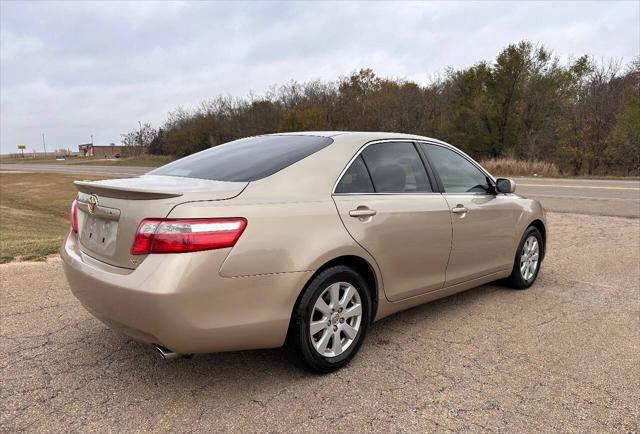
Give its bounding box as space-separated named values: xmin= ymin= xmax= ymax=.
xmin=286 ymin=265 xmax=373 ymax=373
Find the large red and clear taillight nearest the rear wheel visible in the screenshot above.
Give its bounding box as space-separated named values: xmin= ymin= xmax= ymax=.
xmin=131 ymin=218 xmax=247 ymax=255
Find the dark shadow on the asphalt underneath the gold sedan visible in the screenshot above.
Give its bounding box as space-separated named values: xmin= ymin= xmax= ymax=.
xmin=92 ymin=283 xmax=507 ymax=391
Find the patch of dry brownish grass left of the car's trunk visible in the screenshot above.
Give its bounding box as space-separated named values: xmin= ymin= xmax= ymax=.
xmin=0 ymin=172 xmax=107 ymax=263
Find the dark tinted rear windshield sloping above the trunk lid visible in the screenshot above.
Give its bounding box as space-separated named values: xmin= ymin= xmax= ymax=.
xmin=150 ymin=135 xmax=333 ymax=182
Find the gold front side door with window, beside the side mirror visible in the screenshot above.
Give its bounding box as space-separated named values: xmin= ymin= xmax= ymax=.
xmin=420 ymin=143 xmax=517 ymax=286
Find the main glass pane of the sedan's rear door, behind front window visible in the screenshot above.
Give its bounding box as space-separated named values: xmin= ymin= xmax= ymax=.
xmin=362 ymin=142 xmax=432 ymax=193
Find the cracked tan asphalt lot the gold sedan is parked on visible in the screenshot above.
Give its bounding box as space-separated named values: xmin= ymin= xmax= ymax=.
xmin=0 ymin=213 xmax=640 ymax=432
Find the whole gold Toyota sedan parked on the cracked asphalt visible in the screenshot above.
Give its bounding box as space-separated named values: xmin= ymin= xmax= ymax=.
xmin=61 ymin=132 xmax=546 ymax=372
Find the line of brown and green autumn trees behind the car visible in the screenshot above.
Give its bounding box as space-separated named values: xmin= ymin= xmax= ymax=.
xmin=123 ymin=41 xmax=640 ymax=176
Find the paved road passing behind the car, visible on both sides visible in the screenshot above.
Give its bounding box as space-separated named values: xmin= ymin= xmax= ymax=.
xmin=0 ymin=164 xmax=640 ymax=218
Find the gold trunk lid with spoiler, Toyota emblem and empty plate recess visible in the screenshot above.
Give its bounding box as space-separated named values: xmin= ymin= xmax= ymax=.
xmin=75 ymin=175 xmax=248 ymax=269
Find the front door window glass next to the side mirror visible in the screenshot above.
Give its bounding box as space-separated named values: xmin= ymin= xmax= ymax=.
xmin=420 ymin=143 xmax=491 ymax=193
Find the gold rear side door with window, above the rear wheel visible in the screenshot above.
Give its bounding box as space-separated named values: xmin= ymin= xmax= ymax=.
xmin=333 ymin=141 xmax=451 ymax=301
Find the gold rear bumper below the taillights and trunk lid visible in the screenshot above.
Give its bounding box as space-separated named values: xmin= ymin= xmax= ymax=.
xmin=60 ymin=234 xmax=310 ymax=353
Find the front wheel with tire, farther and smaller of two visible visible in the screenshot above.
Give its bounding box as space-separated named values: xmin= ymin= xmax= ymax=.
xmin=507 ymin=226 xmax=545 ymax=289
